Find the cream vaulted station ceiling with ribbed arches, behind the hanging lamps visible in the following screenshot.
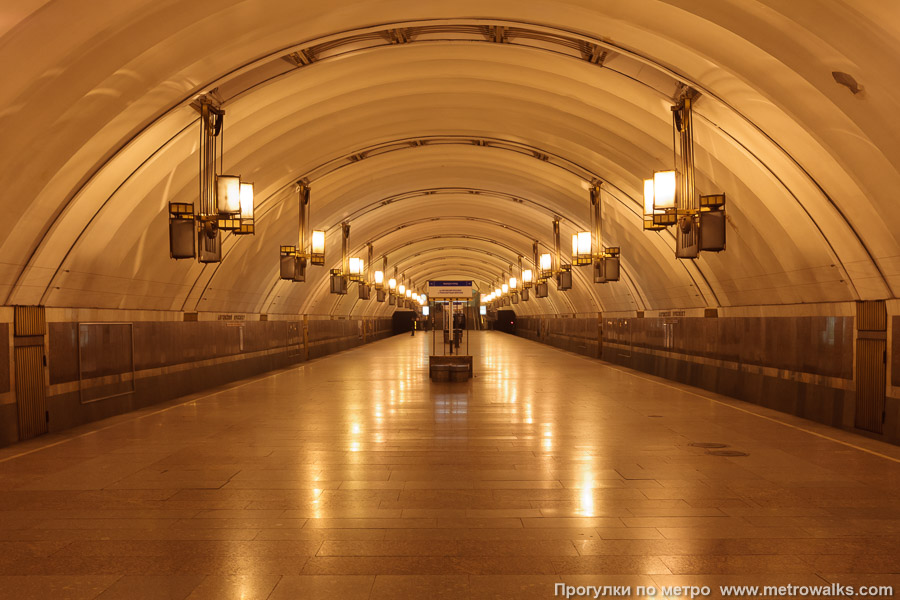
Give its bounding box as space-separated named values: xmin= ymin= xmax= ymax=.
xmin=0 ymin=0 xmax=900 ymax=315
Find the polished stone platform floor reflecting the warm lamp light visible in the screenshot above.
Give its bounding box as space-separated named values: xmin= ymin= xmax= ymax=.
xmin=0 ymin=332 xmax=900 ymax=600
